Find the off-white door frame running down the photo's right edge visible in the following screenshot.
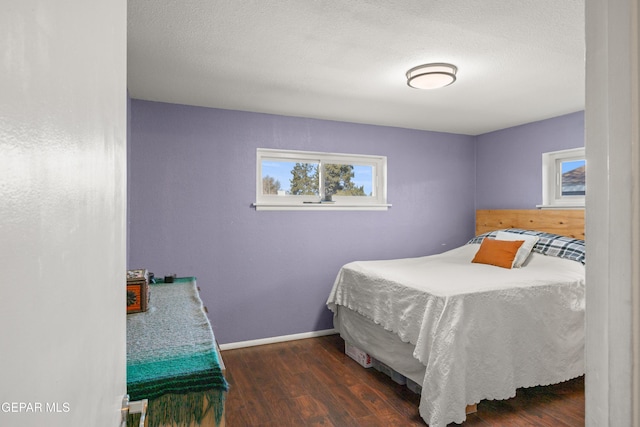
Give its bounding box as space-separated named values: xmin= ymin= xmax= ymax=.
xmin=585 ymin=0 xmax=640 ymax=427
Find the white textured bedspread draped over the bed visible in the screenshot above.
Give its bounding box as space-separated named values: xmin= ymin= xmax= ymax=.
xmin=327 ymin=244 xmax=585 ymax=427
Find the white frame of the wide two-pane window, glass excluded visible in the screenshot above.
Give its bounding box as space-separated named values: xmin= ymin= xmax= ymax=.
xmin=253 ymin=148 xmax=391 ymax=210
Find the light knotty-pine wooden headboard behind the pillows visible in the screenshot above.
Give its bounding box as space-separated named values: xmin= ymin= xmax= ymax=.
xmin=476 ymin=209 xmax=584 ymax=240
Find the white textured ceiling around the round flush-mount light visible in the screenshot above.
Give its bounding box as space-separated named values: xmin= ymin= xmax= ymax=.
xmin=128 ymin=0 xmax=585 ymax=135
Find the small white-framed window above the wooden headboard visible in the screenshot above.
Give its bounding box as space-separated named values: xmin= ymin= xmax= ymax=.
xmin=540 ymin=148 xmax=587 ymax=208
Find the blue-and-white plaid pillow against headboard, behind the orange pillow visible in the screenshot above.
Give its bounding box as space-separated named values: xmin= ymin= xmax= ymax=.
xmin=467 ymin=228 xmax=586 ymax=265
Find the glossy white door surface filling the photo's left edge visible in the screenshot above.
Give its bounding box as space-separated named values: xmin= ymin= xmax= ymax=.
xmin=0 ymin=0 xmax=127 ymax=427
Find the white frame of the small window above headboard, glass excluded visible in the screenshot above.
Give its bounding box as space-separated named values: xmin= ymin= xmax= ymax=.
xmin=538 ymin=147 xmax=586 ymax=209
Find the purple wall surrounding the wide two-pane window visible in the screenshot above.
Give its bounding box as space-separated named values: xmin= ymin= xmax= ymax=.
xmin=129 ymin=100 xmax=476 ymax=343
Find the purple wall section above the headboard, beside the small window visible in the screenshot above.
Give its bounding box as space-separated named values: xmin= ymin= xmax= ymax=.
xmin=476 ymin=111 xmax=584 ymax=209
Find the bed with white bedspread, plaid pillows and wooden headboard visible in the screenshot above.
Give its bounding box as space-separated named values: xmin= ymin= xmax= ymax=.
xmin=327 ymin=210 xmax=585 ymax=427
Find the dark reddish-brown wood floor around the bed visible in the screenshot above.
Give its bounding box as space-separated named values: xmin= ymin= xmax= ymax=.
xmin=222 ymin=335 xmax=584 ymax=427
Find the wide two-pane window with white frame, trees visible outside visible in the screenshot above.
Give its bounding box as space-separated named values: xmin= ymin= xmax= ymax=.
xmin=254 ymin=148 xmax=390 ymax=210
